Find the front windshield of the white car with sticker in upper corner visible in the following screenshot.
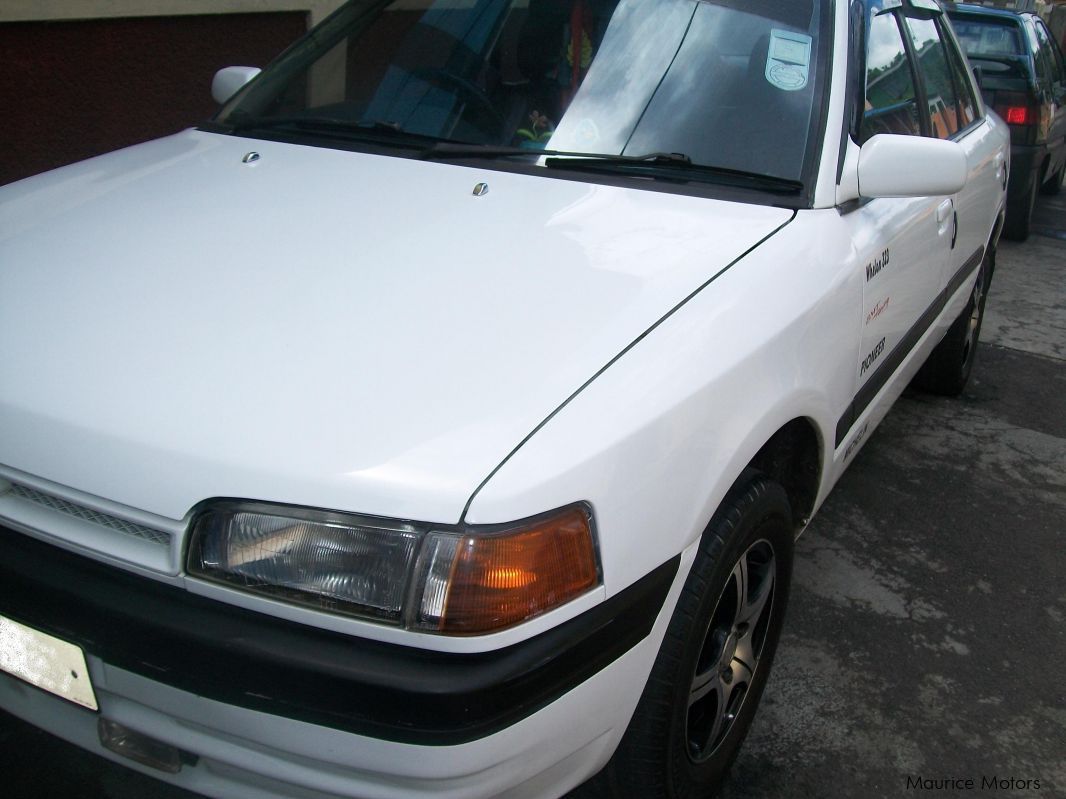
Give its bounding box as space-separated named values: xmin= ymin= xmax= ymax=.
xmin=215 ymin=0 xmax=827 ymax=181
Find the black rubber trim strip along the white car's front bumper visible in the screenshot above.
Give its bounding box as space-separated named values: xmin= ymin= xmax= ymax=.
xmin=0 ymin=526 xmax=680 ymax=746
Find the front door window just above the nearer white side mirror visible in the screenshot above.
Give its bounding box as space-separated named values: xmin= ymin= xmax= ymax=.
xmin=859 ymin=13 xmax=921 ymax=144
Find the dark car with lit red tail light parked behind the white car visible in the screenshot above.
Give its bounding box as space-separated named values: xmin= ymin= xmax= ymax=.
xmin=948 ymin=4 xmax=1066 ymax=241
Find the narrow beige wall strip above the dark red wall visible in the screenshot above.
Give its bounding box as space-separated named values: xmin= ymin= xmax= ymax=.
xmin=0 ymin=0 xmax=343 ymax=25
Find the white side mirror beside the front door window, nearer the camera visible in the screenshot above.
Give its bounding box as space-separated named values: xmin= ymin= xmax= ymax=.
xmin=858 ymin=133 xmax=969 ymax=197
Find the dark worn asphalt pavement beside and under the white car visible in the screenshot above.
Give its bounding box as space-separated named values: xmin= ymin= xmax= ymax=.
xmin=0 ymin=193 xmax=1066 ymax=799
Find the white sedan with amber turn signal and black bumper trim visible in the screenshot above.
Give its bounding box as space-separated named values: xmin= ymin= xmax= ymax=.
xmin=0 ymin=0 xmax=1008 ymax=799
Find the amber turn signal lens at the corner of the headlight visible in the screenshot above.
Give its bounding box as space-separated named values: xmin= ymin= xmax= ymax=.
xmin=422 ymin=508 xmax=599 ymax=635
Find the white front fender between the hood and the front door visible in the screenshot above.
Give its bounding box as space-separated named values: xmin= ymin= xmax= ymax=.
xmin=466 ymin=210 xmax=862 ymax=596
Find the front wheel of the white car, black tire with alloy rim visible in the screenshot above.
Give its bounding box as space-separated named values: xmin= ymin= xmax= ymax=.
xmin=598 ymin=470 xmax=793 ymax=799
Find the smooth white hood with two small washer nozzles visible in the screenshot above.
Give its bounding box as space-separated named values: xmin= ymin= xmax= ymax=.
xmin=0 ymin=131 xmax=791 ymax=522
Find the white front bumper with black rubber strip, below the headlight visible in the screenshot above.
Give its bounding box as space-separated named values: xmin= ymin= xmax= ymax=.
xmin=0 ymin=527 xmax=679 ymax=797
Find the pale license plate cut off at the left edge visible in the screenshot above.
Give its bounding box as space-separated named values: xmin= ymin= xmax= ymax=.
xmin=0 ymin=616 xmax=99 ymax=711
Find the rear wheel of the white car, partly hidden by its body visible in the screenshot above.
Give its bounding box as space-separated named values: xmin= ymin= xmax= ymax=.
xmin=915 ymin=254 xmax=995 ymax=396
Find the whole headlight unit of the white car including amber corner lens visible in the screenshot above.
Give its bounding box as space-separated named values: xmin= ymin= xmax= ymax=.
xmin=188 ymin=503 xmax=600 ymax=635
